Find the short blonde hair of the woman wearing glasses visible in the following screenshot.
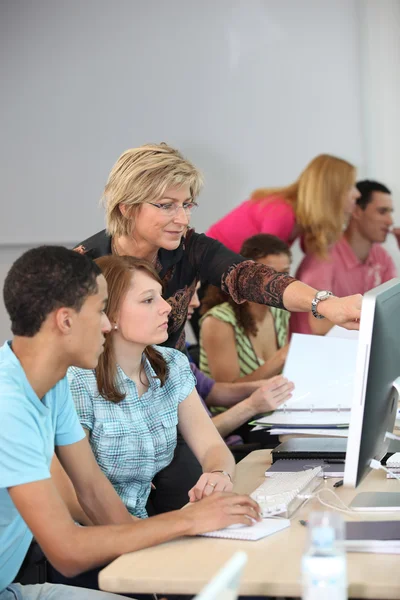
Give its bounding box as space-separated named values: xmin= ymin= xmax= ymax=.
xmin=103 ymin=143 xmax=203 ymax=236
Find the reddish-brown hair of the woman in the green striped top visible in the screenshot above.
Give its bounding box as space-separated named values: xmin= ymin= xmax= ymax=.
xmin=200 ymin=233 xmax=292 ymax=336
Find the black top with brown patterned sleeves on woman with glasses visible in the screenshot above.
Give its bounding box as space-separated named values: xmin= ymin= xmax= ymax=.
xmin=75 ymin=229 xmax=295 ymax=350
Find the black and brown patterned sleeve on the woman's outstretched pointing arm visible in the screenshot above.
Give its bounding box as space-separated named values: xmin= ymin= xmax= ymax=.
xmin=187 ymin=233 xmax=296 ymax=308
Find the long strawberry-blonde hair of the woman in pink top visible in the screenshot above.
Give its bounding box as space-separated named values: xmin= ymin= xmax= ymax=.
xmin=251 ymin=154 xmax=356 ymax=258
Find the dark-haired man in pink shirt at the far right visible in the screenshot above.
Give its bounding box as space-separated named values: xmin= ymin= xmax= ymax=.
xmin=290 ymin=180 xmax=396 ymax=335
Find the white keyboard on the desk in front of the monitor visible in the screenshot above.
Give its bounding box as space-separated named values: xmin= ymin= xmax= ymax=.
xmin=250 ymin=467 xmax=322 ymax=518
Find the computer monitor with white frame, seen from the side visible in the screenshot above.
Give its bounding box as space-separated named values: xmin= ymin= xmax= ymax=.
xmin=344 ymin=279 xmax=400 ymax=509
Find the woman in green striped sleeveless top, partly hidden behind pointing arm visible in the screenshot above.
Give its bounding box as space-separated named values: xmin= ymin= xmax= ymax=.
xmin=200 ymin=234 xmax=291 ymax=382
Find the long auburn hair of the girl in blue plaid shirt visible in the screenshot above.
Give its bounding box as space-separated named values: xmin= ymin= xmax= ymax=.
xmin=95 ymin=254 xmax=168 ymax=403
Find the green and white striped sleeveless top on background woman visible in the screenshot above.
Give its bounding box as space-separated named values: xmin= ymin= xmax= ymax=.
xmin=200 ymin=302 xmax=290 ymax=377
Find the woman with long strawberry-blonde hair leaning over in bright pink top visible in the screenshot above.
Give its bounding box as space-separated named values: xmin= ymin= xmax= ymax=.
xmin=207 ymin=154 xmax=358 ymax=257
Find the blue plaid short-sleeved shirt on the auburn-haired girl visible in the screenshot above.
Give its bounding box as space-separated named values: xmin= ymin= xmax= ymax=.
xmin=68 ymin=346 xmax=196 ymax=518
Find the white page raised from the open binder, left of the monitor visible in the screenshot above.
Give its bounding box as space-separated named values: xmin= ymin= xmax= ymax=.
xmin=275 ymin=333 xmax=358 ymax=412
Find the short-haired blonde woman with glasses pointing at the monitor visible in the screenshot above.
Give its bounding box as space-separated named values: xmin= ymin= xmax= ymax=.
xmin=76 ymin=144 xmax=361 ymax=350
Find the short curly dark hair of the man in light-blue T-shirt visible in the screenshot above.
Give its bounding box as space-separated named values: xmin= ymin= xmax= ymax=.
xmin=3 ymin=246 xmax=101 ymax=337
